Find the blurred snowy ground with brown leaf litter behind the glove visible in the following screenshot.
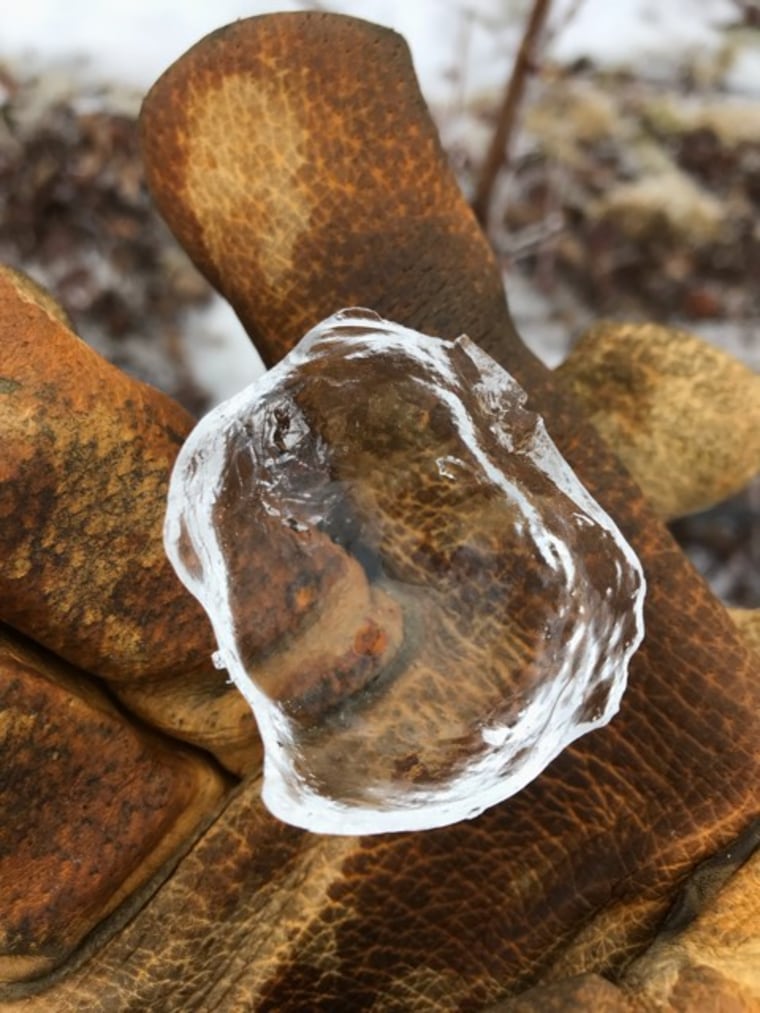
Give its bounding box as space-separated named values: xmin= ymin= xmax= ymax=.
xmin=0 ymin=0 xmax=760 ymax=606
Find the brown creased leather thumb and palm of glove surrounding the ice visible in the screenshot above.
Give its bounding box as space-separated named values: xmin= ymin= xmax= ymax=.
xmin=6 ymin=14 xmax=760 ymax=1011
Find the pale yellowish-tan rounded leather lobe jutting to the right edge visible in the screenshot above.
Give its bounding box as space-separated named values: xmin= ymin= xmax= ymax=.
xmin=556 ymin=321 xmax=760 ymax=518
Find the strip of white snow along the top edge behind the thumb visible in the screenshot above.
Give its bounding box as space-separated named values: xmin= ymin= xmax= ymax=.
xmin=0 ymin=0 xmax=760 ymax=102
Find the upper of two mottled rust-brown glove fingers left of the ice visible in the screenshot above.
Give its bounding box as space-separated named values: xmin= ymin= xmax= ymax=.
xmin=0 ymin=271 xmax=260 ymax=769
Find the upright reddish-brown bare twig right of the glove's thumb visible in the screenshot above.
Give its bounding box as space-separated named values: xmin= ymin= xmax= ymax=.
xmin=472 ymin=0 xmax=551 ymax=226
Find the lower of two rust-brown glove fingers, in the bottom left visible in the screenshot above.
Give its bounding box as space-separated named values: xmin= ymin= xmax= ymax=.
xmin=0 ymin=628 xmax=225 ymax=982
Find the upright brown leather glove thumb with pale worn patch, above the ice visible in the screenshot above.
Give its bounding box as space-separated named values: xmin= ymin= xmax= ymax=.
xmin=141 ymin=13 xmax=512 ymax=365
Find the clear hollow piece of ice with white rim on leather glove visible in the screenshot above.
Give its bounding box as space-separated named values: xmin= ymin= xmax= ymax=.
xmin=165 ymin=310 xmax=644 ymax=834
